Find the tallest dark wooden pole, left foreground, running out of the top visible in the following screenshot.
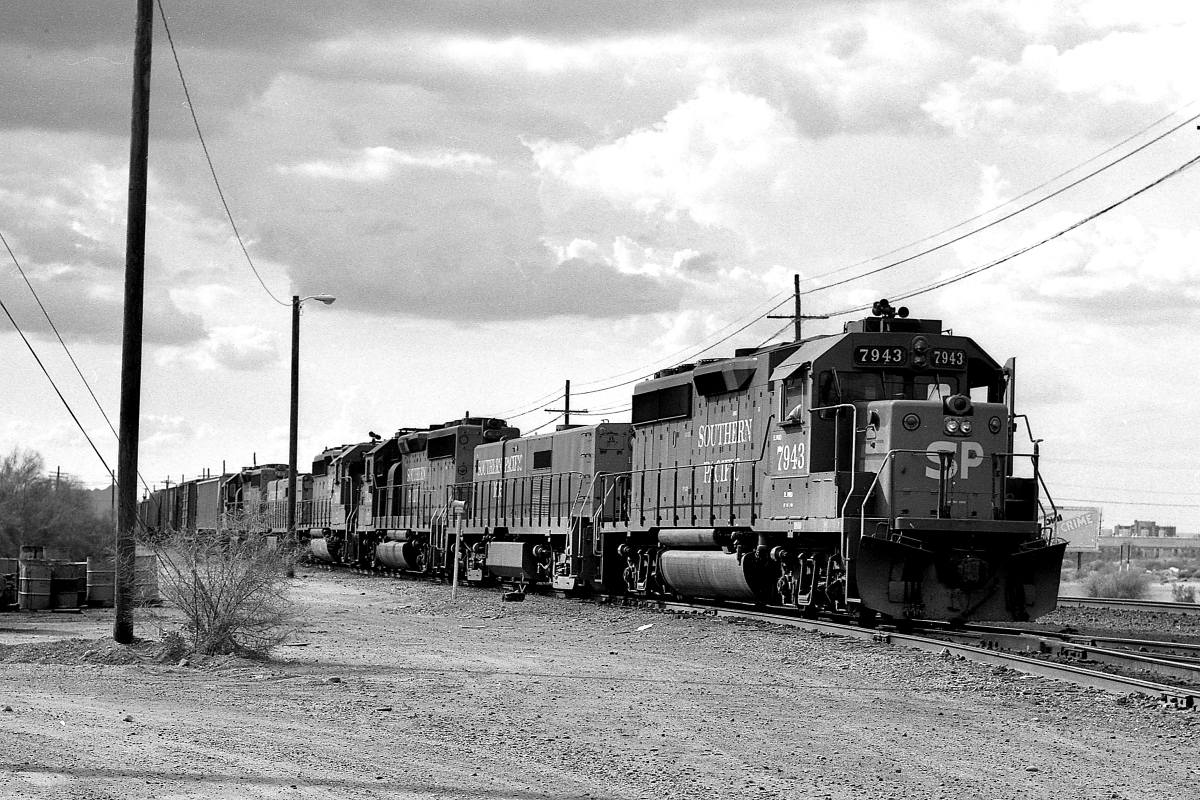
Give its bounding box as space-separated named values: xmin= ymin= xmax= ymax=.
xmin=113 ymin=0 xmax=154 ymax=644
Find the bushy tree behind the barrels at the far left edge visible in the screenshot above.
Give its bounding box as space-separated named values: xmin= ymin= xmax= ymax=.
xmin=0 ymin=447 xmax=112 ymax=560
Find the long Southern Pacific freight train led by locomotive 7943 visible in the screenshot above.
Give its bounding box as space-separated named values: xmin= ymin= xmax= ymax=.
xmin=142 ymin=301 xmax=1066 ymax=622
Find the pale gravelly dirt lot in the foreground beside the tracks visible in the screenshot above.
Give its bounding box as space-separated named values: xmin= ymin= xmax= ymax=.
xmin=0 ymin=572 xmax=1200 ymax=800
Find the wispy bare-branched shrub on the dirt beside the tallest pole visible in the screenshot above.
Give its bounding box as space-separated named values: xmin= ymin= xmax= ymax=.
xmin=142 ymin=521 xmax=300 ymax=656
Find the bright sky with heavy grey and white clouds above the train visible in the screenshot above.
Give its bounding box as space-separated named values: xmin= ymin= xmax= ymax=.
xmin=0 ymin=0 xmax=1200 ymax=533
